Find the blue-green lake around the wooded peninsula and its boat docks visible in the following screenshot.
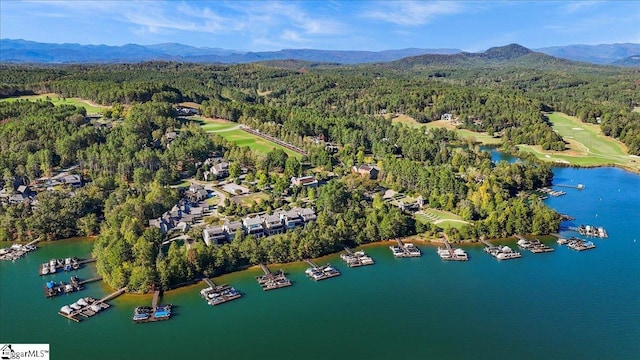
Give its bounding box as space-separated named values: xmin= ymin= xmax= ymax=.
xmin=0 ymin=168 xmax=640 ymax=359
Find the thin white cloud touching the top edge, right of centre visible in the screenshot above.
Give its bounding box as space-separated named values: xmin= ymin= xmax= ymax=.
xmin=362 ymin=1 xmax=464 ymax=26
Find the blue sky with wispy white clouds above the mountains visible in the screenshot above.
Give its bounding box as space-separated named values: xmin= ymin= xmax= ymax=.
xmin=0 ymin=0 xmax=640 ymax=51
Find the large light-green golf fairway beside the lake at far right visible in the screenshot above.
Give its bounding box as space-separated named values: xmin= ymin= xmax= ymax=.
xmin=518 ymin=112 xmax=640 ymax=172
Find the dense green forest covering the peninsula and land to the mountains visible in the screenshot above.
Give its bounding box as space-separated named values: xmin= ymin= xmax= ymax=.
xmin=0 ymin=52 xmax=640 ymax=291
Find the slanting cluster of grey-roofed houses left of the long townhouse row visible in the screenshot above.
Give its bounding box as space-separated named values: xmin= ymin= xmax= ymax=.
xmin=149 ymin=184 xmax=209 ymax=234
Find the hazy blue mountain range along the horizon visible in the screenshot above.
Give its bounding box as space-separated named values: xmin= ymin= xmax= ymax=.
xmin=0 ymin=39 xmax=640 ymax=66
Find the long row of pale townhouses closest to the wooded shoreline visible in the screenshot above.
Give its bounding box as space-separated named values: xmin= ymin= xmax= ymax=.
xmin=202 ymin=208 xmax=316 ymax=245
